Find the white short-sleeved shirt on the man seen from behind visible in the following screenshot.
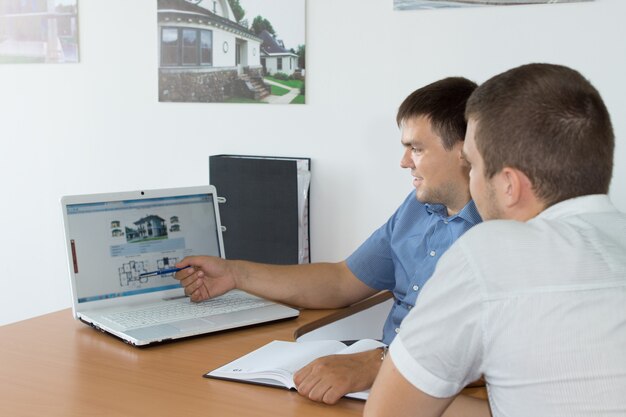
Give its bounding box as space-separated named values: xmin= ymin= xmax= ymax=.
xmin=390 ymin=195 xmax=626 ymax=417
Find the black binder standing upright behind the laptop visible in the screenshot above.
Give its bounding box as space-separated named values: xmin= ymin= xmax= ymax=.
xmin=209 ymin=155 xmax=311 ymax=265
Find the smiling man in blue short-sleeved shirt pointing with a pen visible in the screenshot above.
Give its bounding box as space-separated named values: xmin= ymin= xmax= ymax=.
xmin=176 ymin=77 xmax=480 ymax=404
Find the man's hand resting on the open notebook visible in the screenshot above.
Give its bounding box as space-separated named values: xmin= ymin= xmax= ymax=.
xmin=293 ymin=349 xmax=381 ymax=404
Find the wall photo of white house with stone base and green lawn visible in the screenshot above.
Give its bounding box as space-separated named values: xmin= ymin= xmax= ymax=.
xmin=157 ymin=0 xmax=306 ymax=104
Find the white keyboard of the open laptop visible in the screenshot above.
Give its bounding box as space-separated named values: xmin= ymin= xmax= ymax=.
xmin=104 ymin=291 xmax=274 ymax=329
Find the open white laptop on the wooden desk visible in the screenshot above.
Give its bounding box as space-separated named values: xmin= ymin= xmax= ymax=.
xmin=61 ymin=185 xmax=299 ymax=346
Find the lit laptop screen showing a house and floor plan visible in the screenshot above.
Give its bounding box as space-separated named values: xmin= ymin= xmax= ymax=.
xmin=66 ymin=194 xmax=222 ymax=303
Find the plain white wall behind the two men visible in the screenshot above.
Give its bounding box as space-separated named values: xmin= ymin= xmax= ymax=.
xmin=0 ymin=0 xmax=626 ymax=324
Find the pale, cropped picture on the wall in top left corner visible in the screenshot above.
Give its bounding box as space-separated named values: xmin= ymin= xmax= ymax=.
xmin=0 ymin=0 xmax=78 ymax=64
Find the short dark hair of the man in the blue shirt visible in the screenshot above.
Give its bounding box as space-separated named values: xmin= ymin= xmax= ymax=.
xmin=396 ymin=77 xmax=477 ymax=150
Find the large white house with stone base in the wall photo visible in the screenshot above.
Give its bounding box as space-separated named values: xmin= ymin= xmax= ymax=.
xmin=157 ymin=0 xmax=269 ymax=102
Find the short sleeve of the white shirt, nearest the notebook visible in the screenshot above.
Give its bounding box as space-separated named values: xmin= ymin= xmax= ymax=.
xmin=390 ymin=237 xmax=483 ymax=398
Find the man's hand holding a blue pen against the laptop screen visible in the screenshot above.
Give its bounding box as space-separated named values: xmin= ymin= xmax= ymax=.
xmin=174 ymin=256 xmax=235 ymax=302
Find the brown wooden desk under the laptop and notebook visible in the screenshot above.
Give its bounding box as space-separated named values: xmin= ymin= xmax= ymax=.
xmin=0 ymin=304 xmax=486 ymax=417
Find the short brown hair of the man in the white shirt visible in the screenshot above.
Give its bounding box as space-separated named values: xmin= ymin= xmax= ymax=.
xmin=465 ymin=64 xmax=615 ymax=207
